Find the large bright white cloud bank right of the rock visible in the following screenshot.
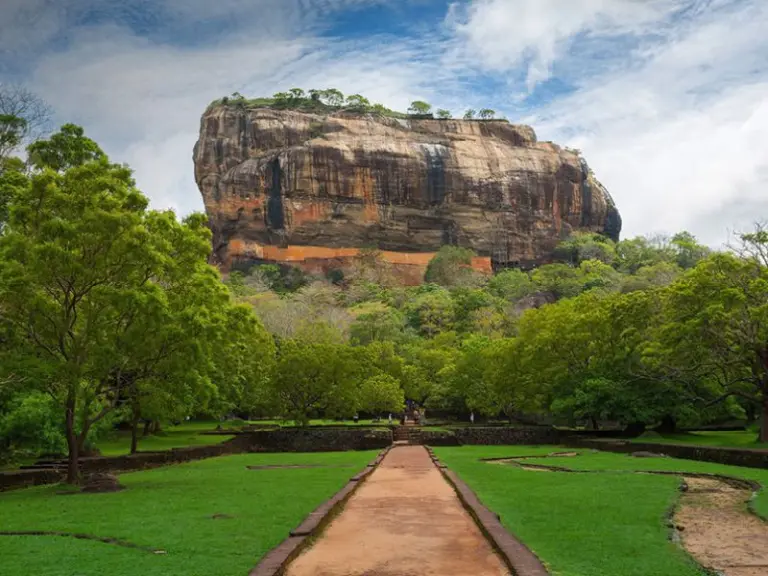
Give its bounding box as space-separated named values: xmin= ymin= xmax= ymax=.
xmin=531 ymin=3 xmax=768 ymax=245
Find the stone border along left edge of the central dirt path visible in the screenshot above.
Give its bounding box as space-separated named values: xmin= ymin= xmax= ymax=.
xmin=248 ymin=446 xmax=391 ymax=576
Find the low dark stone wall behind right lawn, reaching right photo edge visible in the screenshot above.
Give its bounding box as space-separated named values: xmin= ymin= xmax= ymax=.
xmin=562 ymin=437 xmax=768 ymax=468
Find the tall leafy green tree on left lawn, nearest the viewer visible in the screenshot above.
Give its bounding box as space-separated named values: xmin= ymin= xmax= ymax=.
xmin=0 ymin=125 xmax=161 ymax=482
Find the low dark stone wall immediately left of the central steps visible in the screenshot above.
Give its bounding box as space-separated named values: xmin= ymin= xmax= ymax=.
xmin=236 ymin=427 xmax=392 ymax=452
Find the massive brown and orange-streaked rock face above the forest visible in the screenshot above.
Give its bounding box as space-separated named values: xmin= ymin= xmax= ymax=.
xmin=194 ymin=105 xmax=621 ymax=283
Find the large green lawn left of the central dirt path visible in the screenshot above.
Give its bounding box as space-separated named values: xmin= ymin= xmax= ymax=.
xmin=0 ymin=452 xmax=376 ymax=576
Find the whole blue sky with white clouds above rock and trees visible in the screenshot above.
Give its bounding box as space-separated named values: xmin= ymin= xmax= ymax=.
xmin=0 ymin=0 xmax=768 ymax=246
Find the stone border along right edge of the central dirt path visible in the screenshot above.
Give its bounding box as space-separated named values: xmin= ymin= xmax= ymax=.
xmin=426 ymin=446 xmax=549 ymax=576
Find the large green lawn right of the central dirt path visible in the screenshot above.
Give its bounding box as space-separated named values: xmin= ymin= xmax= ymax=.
xmin=435 ymin=446 xmax=768 ymax=576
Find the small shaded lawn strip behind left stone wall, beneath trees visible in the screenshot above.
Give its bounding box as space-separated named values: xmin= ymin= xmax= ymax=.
xmin=96 ymin=421 xmax=232 ymax=456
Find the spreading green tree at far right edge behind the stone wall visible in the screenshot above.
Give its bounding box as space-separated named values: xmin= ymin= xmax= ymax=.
xmin=647 ymin=254 xmax=768 ymax=442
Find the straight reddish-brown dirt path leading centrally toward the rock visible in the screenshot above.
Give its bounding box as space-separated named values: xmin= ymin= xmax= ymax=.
xmin=286 ymin=446 xmax=509 ymax=576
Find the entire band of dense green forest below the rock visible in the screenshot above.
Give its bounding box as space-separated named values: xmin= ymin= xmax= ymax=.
xmin=0 ymin=84 xmax=768 ymax=480
